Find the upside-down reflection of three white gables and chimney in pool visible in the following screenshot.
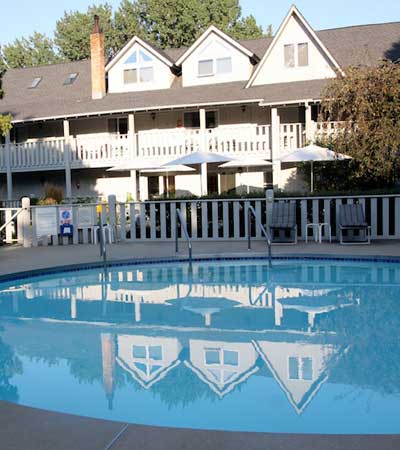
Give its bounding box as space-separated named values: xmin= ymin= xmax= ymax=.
xmin=101 ymin=334 xmax=345 ymax=414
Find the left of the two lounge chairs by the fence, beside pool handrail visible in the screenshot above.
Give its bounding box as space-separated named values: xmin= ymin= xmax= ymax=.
xmin=269 ymin=202 xmax=297 ymax=244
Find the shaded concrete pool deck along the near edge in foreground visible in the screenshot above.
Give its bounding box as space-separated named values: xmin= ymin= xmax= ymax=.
xmin=0 ymin=402 xmax=400 ymax=450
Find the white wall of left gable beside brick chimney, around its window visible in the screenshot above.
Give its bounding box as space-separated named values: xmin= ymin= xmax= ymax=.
xmin=108 ymin=43 xmax=174 ymax=93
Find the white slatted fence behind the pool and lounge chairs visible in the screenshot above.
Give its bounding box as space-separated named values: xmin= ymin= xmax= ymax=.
xmin=13 ymin=195 xmax=400 ymax=246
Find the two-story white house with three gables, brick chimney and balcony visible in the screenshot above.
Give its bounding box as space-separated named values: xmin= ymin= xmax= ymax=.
xmin=0 ymin=6 xmax=400 ymax=200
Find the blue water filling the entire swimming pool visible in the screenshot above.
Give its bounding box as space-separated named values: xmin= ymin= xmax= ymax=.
xmin=0 ymin=260 xmax=400 ymax=434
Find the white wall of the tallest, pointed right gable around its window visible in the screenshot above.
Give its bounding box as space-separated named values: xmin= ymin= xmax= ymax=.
xmin=253 ymin=16 xmax=335 ymax=86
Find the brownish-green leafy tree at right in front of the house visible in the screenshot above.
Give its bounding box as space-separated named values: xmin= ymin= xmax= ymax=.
xmin=321 ymin=61 xmax=400 ymax=184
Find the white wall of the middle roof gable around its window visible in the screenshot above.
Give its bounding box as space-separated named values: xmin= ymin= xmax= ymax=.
xmin=182 ymin=33 xmax=253 ymax=86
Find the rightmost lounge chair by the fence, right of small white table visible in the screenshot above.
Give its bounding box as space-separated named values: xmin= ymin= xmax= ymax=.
xmin=339 ymin=203 xmax=371 ymax=244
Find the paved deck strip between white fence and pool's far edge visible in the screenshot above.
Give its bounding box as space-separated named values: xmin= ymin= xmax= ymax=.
xmin=0 ymin=241 xmax=400 ymax=275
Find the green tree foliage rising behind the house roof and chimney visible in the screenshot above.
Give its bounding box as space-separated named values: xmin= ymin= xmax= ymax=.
xmin=0 ymin=0 xmax=271 ymax=68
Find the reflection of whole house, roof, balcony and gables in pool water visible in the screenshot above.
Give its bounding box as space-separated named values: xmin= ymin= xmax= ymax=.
xmin=0 ymin=262 xmax=400 ymax=434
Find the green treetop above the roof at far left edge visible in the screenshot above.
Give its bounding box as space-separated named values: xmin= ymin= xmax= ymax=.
xmin=2 ymin=32 xmax=60 ymax=68
